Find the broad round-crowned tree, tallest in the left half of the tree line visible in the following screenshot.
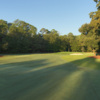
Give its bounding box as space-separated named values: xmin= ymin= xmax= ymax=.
xmin=8 ymin=20 xmax=37 ymax=53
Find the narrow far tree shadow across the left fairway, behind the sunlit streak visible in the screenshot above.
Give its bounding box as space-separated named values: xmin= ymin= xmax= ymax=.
xmin=0 ymin=59 xmax=48 ymax=71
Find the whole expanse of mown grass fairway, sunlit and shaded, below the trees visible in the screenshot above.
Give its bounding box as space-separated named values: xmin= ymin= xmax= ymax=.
xmin=0 ymin=53 xmax=100 ymax=100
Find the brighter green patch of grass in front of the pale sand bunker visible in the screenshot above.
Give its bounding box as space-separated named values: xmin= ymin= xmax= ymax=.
xmin=62 ymin=53 xmax=100 ymax=69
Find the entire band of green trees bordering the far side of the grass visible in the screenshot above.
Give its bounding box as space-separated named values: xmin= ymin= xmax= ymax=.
xmin=0 ymin=0 xmax=100 ymax=53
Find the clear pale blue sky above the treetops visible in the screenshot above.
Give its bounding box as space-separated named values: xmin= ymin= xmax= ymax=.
xmin=0 ymin=0 xmax=96 ymax=35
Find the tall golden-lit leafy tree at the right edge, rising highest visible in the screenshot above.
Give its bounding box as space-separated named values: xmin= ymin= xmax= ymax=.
xmin=79 ymin=0 xmax=100 ymax=52
